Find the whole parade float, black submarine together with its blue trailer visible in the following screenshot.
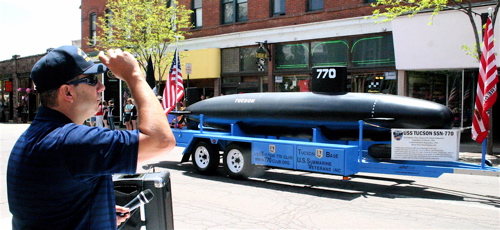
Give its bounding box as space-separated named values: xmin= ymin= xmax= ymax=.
xmin=171 ymin=66 xmax=500 ymax=179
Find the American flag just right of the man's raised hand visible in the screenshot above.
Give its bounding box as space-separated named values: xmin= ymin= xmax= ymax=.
xmin=163 ymin=49 xmax=184 ymax=114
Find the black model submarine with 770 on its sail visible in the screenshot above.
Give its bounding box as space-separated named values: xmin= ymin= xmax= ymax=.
xmin=176 ymin=67 xmax=454 ymax=140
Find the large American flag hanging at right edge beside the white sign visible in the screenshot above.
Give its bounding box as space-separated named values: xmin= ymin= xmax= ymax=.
xmin=472 ymin=16 xmax=498 ymax=143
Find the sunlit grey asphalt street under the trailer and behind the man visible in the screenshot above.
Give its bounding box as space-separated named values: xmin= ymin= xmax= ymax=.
xmin=0 ymin=124 xmax=500 ymax=229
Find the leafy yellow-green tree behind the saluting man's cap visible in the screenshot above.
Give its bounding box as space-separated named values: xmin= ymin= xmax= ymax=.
xmin=96 ymin=0 xmax=192 ymax=81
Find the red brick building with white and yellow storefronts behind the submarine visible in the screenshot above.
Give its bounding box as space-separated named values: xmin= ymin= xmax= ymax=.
xmin=0 ymin=0 xmax=500 ymax=137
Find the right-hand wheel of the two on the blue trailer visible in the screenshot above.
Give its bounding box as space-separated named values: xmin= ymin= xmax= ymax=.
xmin=223 ymin=143 xmax=254 ymax=180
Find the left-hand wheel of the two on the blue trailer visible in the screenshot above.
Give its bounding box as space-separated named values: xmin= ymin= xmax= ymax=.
xmin=192 ymin=141 xmax=220 ymax=175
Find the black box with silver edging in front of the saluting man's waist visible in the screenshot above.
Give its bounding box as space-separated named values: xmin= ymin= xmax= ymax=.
xmin=113 ymin=171 xmax=174 ymax=230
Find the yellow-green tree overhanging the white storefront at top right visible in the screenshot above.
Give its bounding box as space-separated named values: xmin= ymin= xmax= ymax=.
xmin=370 ymin=0 xmax=500 ymax=60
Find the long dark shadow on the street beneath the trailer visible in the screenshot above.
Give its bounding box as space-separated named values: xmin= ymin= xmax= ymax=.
xmin=143 ymin=161 xmax=500 ymax=208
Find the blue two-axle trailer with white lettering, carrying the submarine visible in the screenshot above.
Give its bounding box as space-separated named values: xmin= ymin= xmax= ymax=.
xmin=173 ymin=115 xmax=500 ymax=179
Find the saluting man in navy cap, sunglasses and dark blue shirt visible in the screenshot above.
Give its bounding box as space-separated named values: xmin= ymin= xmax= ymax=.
xmin=7 ymin=46 xmax=175 ymax=229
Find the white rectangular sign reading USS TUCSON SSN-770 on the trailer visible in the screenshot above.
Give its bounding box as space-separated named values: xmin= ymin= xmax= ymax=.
xmin=391 ymin=129 xmax=460 ymax=161
